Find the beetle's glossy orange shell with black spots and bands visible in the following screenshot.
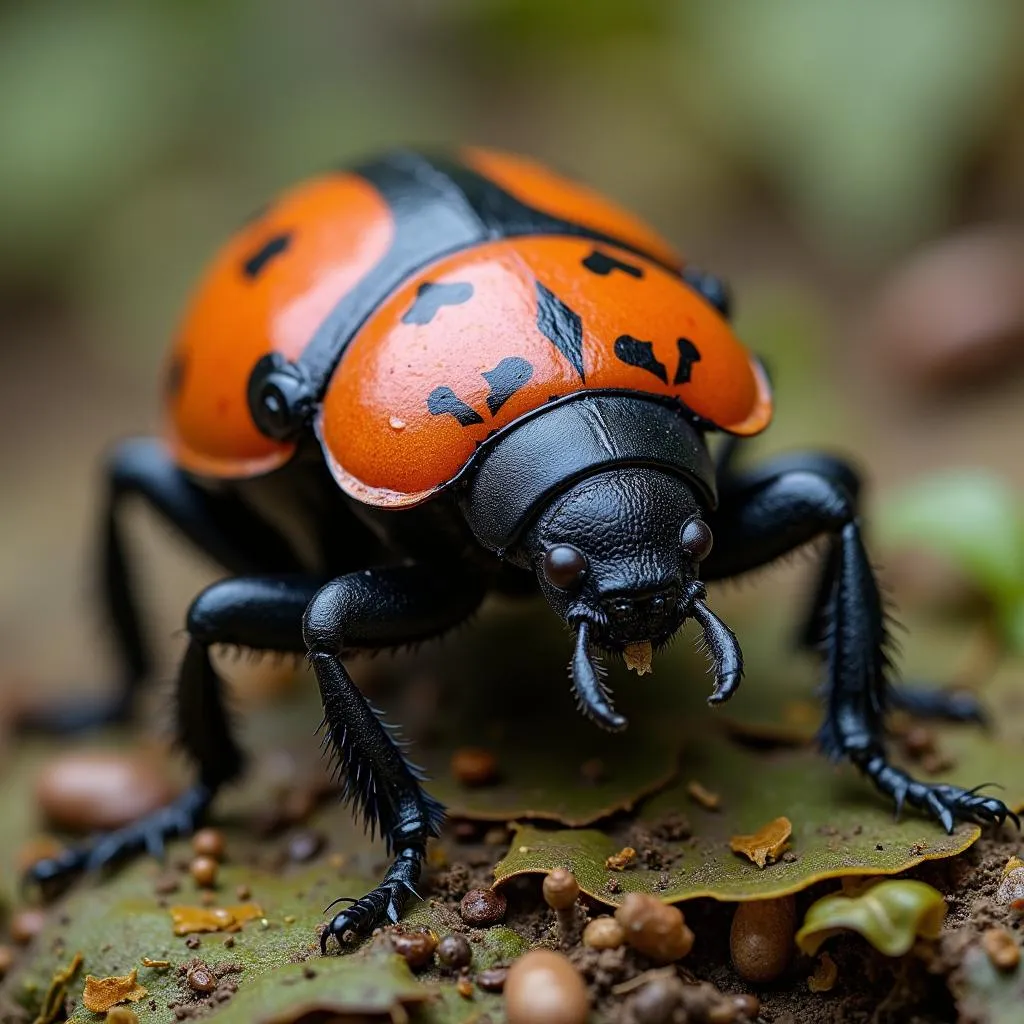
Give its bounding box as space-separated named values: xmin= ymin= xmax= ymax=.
xmin=161 ymin=150 xmax=771 ymax=508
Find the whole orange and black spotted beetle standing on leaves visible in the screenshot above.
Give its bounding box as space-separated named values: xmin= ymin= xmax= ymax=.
xmin=33 ymin=148 xmax=1013 ymax=951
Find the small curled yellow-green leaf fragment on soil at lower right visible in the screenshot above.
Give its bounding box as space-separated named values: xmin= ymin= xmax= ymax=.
xmin=797 ymin=879 xmax=946 ymax=956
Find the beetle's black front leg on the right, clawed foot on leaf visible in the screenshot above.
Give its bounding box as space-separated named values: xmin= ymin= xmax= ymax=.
xmin=701 ymin=456 xmax=1012 ymax=830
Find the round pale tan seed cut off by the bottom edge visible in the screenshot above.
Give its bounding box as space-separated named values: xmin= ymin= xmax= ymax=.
xmin=505 ymin=949 xmax=590 ymax=1024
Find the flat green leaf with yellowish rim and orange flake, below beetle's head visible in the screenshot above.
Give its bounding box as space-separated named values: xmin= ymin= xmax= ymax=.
xmin=495 ymin=727 xmax=980 ymax=904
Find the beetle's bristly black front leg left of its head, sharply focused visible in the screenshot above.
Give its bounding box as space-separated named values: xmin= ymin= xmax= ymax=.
xmin=304 ymin=565 xmax=484 ymax=952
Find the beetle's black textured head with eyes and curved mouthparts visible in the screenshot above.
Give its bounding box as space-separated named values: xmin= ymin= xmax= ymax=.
xmin=519 ymin=466 xmax=741 ymax=729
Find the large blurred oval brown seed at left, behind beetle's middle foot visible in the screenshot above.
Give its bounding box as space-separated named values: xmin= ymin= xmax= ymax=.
xmin=36 ymin=751 xmax=175 ymax=833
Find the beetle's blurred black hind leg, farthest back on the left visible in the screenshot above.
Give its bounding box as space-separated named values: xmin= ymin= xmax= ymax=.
xmin=19 ymin=438 xmax=299 ymax=732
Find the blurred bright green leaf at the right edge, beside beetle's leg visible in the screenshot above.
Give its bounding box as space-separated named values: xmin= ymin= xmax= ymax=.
xmin=877 ymin=470 xmax=1024 ymax=605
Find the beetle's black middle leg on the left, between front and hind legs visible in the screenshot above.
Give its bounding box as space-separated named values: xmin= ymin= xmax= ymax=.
xmin=30 ymin=577 xmax=323 ymax=883
